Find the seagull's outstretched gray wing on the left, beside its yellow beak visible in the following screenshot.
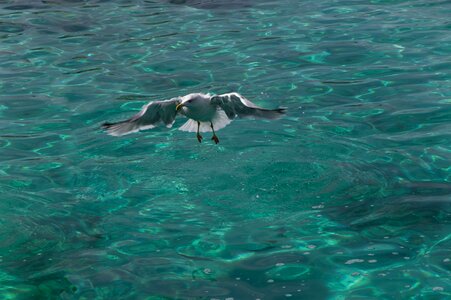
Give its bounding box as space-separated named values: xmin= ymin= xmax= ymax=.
xmin=102 ymin=98 xmax=181 ymax=136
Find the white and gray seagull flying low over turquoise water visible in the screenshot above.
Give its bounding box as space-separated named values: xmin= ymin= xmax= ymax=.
xmin=102 ymin=93 xmax=286 ymax=144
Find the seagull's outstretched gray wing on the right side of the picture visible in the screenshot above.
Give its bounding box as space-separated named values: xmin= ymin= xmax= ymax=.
xmin=210 ymin=93 xmax=286 ymax=119
